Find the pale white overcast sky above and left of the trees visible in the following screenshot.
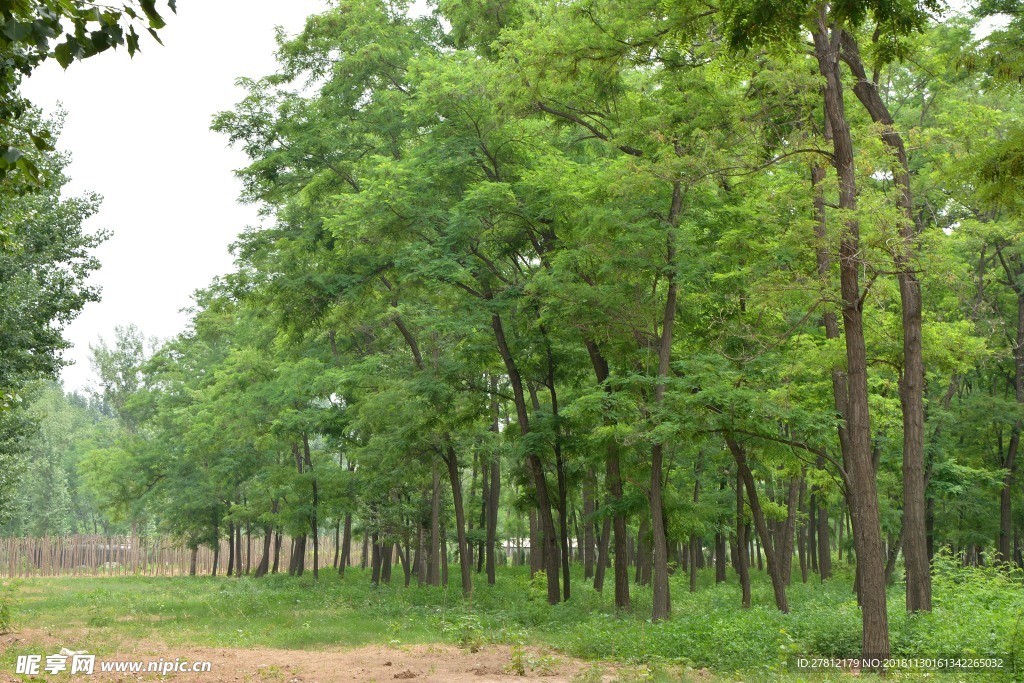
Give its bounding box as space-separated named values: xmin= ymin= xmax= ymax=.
xmin=23 ymin=0 xmax=326 ymax=390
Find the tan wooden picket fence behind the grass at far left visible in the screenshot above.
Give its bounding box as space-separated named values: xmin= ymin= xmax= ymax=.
xmin=0 ymin=535 xmax=361 ymax=579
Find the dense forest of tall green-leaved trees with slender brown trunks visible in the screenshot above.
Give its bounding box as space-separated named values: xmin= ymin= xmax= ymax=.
xmin=0 ymin=0 xmax=1024 ymax=680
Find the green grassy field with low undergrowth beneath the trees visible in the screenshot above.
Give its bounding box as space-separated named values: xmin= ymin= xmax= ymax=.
xmin=0 ymin=565 xmax=1024 ymax=681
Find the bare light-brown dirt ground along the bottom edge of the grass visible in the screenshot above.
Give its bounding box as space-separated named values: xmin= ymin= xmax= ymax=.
xmin=0 ymin=630 xmax=615 ymax=683
